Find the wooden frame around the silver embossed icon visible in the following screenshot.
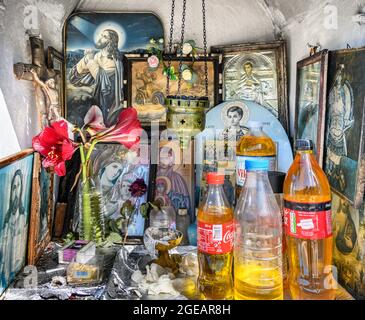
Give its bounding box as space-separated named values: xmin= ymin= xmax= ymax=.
xmin=211 ymin=40 xmax=289 ymax=133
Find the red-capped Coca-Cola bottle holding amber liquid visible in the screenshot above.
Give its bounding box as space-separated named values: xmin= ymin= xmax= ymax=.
xmin=197 ymin=172 xmax=234 ymax=300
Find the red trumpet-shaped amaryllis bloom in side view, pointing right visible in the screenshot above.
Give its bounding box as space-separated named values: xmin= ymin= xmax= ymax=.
xmin=96 ymin=108 xmax=142 ymax=149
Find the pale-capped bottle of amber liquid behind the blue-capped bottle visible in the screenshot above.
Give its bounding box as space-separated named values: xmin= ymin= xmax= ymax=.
xmin=236 ymin=121 xmax=276 ymax=199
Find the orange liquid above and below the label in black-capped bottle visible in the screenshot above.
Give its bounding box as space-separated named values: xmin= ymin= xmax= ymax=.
xmin=284 ymin=151 xmax=335 ymax=300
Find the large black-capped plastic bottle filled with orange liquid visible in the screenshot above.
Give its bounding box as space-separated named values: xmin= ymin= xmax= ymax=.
xmin=284 ymin=139 xmax=334 ymax=300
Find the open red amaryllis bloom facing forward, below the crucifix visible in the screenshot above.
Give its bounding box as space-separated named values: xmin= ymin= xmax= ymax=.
xmin=32 ymin=120 xmax=75 ymax=177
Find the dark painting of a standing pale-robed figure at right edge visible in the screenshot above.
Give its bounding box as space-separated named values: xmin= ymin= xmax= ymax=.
xmin=324 ymin=48 xmax=365 ymax=208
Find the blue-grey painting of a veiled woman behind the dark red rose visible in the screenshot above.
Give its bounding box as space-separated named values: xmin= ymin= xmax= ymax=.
xmin=91 ymin=143 xmax=150 ymax=239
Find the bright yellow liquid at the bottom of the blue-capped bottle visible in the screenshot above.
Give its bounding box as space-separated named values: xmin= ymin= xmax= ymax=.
xmin=234 ymin=263 xmax=284 ymax=300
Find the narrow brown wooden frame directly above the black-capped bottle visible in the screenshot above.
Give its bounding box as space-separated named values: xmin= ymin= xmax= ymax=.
xmin=294 ymin=50 xmax=328 ymax=167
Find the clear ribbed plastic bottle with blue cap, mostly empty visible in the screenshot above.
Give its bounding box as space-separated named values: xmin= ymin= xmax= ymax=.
xmin=234 ymin=159 xmax=283 ymax=300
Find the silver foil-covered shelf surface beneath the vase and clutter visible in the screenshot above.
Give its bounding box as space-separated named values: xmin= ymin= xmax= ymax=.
xmin=0 ymin=242 xmax=353 ymax=300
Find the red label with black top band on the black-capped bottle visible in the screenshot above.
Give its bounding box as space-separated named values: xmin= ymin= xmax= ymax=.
xmin=284 ymin=200 xmax=332 ymax=240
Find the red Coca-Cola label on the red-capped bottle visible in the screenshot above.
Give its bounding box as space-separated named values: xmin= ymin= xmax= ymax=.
xmin=198 ymin=220 xmax=234 ymax=254
